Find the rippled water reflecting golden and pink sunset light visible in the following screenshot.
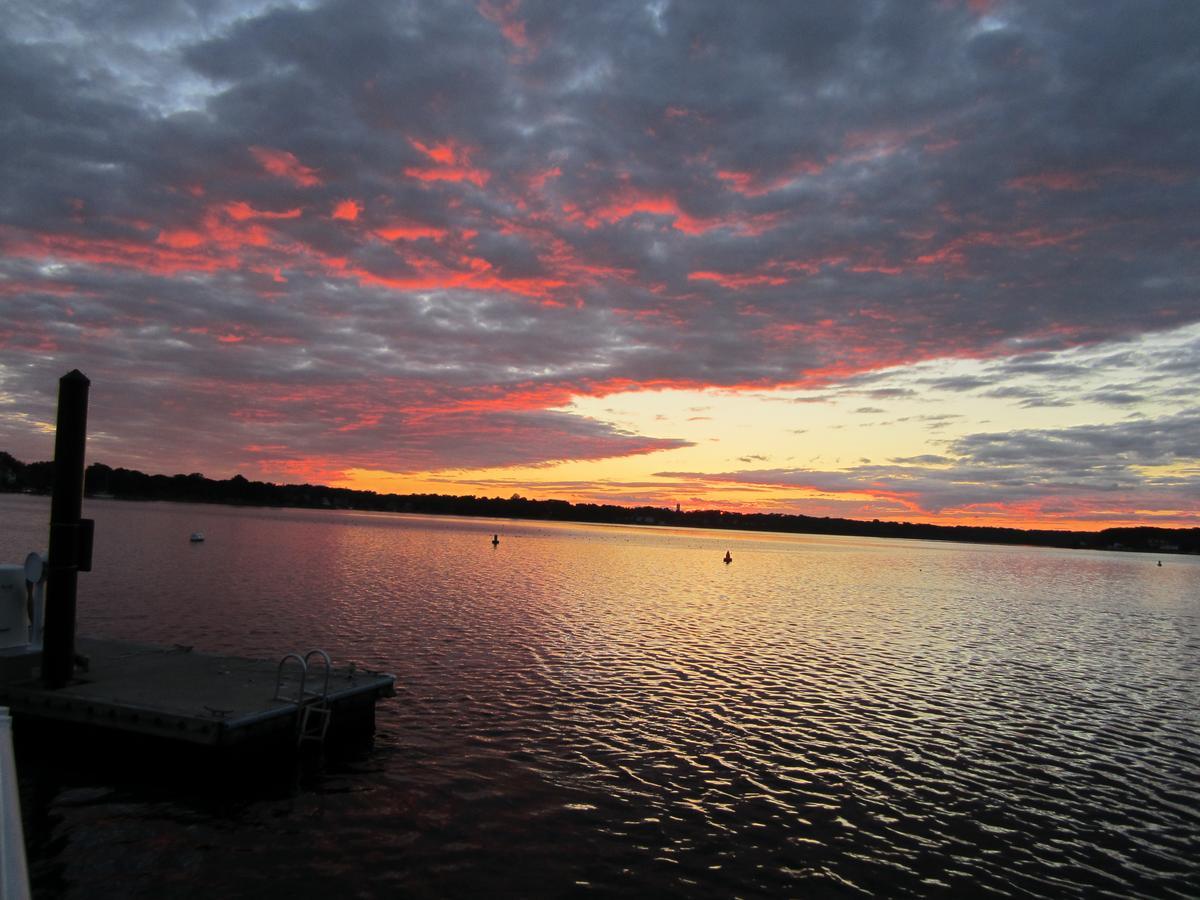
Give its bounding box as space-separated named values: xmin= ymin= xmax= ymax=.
xmin=0 ymin=496 xmax=1200 ymax=898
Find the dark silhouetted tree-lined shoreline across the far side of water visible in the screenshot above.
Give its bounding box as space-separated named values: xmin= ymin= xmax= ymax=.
xmin=0 ymin=451 xmax=1200 ymax=554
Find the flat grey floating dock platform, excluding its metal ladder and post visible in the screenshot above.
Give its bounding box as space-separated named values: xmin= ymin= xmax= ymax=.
xmin=0 ymin=637 xmax=395 ymax=749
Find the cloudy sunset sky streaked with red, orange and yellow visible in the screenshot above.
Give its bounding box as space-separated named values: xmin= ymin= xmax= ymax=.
xmin=0 ymin=0 xmax=1200 ymax=528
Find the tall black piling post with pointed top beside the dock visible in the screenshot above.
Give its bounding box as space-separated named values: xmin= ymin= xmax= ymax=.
xmin=42 ymin=368 xmax=91 ymax=688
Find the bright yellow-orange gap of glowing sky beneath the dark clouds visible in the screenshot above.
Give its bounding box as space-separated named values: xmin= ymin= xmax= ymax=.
xmin=319 ymin=335 xmax=1196 ymax=530
